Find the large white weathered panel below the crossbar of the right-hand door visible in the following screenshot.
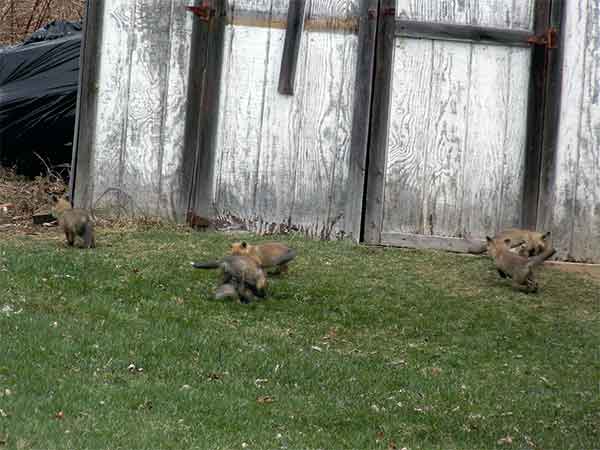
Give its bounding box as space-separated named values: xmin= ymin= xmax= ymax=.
xmin=382 ymin=39 xmax=530 ymax=238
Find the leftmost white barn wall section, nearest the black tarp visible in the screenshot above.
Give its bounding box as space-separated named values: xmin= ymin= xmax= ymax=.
xmin=81 ymin=0 xmax=193 ymax=218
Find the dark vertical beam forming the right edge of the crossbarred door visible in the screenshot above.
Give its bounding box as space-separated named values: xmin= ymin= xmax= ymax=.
xmin=521 ymin=0 xmax=561 ymax=228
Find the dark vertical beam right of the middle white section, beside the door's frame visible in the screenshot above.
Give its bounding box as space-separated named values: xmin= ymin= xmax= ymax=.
xmin=344 ymin=0 xmax=379 ymax=241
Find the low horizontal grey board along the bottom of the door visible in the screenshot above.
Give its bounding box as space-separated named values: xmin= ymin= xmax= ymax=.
xmin=381 ymin=233 xmax=485 ymax=253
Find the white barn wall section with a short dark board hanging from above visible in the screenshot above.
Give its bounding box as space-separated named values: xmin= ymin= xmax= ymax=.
xmin=213 ymin=0 xmax=358 ymax=237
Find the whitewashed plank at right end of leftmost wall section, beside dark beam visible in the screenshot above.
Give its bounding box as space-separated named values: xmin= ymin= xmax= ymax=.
xmin=159 ymin=0 xmax=195 ymax=222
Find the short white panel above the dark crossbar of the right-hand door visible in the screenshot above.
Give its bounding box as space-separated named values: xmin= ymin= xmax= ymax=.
xmin=396 ymin=0 xmax=535 ymax=30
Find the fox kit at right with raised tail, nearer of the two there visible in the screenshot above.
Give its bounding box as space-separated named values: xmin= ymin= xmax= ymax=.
xmin=486 ymin=236 xmax=556 ymax=293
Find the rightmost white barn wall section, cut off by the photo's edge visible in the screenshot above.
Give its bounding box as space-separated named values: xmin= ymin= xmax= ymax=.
xmin=539 ymin=0 xmax=600 ymax=263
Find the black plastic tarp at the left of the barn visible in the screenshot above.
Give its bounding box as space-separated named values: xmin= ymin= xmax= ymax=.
xmin=0 ymin=22 xmax=81 ymax=175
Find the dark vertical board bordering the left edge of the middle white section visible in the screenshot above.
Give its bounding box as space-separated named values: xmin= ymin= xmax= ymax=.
xmin=190 ymin=0 xmax=226 ymax=217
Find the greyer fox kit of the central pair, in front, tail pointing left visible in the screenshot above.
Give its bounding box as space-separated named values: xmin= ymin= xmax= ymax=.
xmin=192 ymin=255 xmax=267 ymax=303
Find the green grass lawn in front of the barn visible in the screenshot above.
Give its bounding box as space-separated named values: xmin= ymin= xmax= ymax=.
xmin=0 ymin=229 xmax=600 ymax=450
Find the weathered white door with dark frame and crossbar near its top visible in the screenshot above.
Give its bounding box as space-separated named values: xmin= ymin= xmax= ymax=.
xmin=364 ymin=0 xmax=550 ymax=251
